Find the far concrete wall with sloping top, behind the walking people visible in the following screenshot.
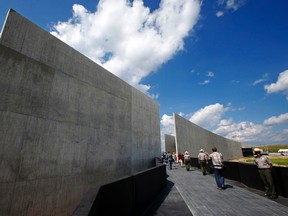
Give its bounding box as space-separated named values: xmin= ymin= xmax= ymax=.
xmin=174 ymin=113 xmax=242 ymax=160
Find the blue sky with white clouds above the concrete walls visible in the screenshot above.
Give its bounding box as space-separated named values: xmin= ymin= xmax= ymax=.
xmin=0 ymin=0 xmax=288 ymax=148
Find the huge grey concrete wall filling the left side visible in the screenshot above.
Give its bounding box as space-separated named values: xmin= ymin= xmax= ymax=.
xmin=0 ymin=10 xmax=161 ymax=216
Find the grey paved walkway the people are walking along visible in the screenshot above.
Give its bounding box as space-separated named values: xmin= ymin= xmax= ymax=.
xmin=144 ymin=165 xmax=288 ymax=216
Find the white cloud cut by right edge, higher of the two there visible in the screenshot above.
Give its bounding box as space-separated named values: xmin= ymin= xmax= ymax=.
xmin=264 ymin=70 xmax=288 ymax=100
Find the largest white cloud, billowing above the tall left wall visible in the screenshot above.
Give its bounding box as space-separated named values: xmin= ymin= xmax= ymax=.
xmin=51 ymin=0 xmax=201 ymax=93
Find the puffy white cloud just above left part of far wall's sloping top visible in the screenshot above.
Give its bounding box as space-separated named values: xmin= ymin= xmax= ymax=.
xmin=189 ymin=103 xmax=229 ymax=128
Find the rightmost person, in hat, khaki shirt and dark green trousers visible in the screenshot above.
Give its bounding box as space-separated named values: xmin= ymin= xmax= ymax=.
xmin=254 ymin=148 xmax=277 ymax=199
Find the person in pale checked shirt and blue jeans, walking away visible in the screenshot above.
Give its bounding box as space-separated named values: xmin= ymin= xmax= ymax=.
xmin=210 ymin=147 xmax=225 ymax=190
